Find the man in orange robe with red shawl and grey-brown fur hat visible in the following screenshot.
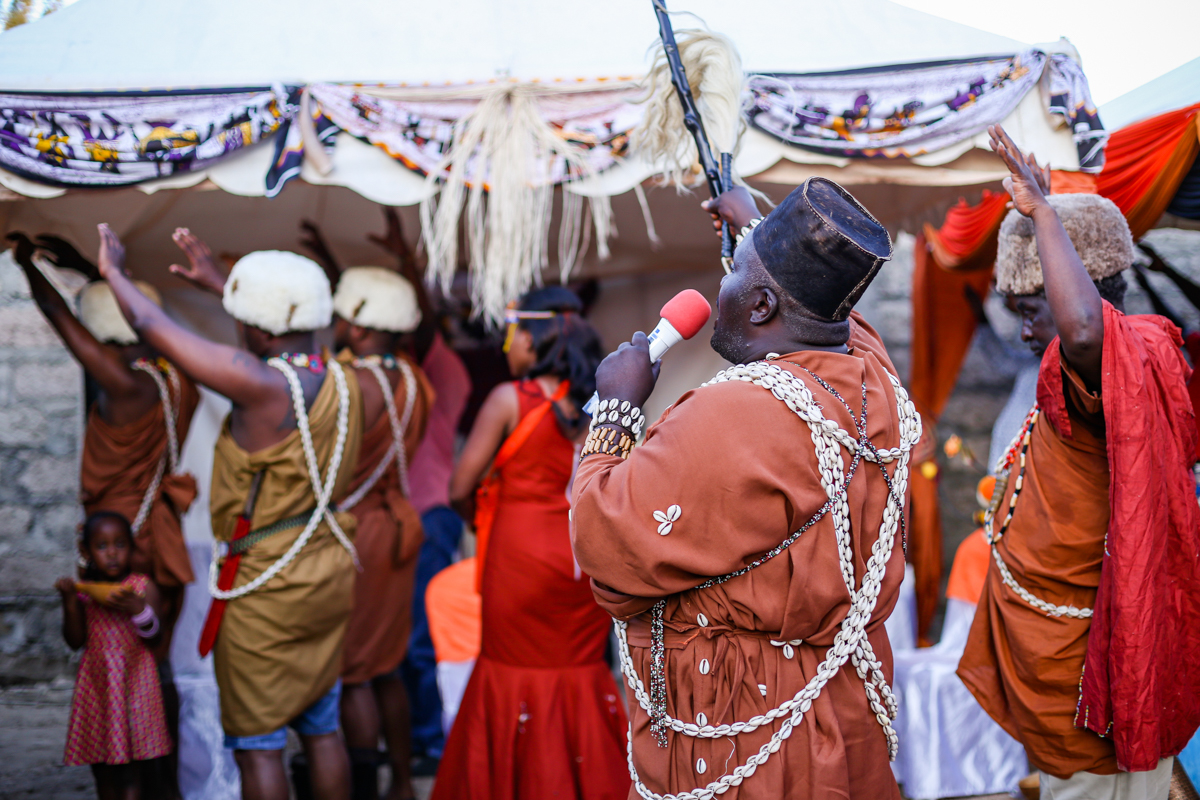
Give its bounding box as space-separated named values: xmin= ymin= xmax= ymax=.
xmin=959 ymin=128 xmax=1200 ymax=800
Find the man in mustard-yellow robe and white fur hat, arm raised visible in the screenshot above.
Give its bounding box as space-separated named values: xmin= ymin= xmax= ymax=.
xmin=100 ymin=225 xmax=362 ymax=800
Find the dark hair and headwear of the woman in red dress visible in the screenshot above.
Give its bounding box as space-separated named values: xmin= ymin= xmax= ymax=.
xmin=517 ymin=287 xmax=604 ymax=409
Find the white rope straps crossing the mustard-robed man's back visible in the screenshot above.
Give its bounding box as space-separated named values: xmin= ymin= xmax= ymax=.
xmin=209 ymin=359 xmax=352 ymax=600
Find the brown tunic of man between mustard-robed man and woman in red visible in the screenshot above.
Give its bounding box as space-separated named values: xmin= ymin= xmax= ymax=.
xmin=338 ymin=354 xmax=433 ymax=684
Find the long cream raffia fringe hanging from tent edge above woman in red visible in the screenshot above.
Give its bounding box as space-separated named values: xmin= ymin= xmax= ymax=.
xmin=403 ymin=83 xmax=617 ymax=323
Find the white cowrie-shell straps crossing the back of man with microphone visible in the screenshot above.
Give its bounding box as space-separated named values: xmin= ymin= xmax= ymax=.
xmin=616 ymin=361 xmax=922 ymax=800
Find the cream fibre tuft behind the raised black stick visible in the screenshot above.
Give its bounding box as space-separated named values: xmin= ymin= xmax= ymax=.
xmin=630 ymin=29 xmax=745 ymax=191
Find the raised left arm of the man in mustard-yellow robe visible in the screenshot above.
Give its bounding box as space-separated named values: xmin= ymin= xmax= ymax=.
xmin=93 ymin=224 xmax=282 ymax=407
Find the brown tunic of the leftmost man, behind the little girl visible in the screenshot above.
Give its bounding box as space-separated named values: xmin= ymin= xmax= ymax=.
xmin=79 ymin=373 xmax=200 ymax=588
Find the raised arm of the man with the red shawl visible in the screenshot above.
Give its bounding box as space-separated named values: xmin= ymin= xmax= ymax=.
xmin=988 ymin=125 xmax=1104 ymax=389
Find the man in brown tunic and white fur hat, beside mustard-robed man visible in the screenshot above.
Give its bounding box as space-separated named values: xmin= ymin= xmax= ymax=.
xmin=334 ymin=266 xmax=433 ymax=800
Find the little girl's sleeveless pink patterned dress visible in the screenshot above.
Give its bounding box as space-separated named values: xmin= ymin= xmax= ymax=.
xmin=62 ymin=575 xmax=172 ymax=766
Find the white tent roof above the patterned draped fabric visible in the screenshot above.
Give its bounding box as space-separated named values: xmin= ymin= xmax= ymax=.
xmin=0 ymin=0 xmax=1026 ymax=92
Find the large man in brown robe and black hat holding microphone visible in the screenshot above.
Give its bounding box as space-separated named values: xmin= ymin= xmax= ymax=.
xmin=572 ymin=179 xmax=920 ymax=800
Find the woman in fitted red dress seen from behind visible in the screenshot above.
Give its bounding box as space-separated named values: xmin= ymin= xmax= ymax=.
xmin=433 ymin=287 xmax=630 ymax=800
